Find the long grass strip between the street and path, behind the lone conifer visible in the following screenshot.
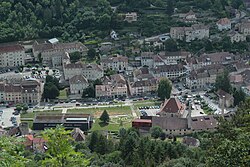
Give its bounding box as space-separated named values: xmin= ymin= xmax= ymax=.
xmin=67 ymin=106 xmax=132 ymax=117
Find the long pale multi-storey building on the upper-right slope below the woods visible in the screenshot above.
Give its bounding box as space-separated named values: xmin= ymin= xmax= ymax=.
xmin=170 ymin=24 xmax=209 ymax=42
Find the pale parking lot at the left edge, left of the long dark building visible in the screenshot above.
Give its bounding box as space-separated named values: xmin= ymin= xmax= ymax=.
xmin=0 ymin=107 xmax=20 ymax=128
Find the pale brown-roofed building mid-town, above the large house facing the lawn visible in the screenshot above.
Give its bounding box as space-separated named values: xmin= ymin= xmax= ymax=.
xmin=101 ymin=55 xmax=128 ymax=72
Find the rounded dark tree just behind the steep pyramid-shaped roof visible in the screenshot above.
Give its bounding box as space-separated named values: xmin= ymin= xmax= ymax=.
xmin=157 ymin=78 xmax=172 ymax=100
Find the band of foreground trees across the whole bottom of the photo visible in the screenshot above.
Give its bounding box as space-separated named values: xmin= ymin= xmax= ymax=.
xmin=0 ymin=99 xmax=250 ymax=167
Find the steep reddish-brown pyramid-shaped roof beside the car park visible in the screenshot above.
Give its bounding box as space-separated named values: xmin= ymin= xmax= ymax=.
xmin=157 ymin=97 xmax=185 ymax=114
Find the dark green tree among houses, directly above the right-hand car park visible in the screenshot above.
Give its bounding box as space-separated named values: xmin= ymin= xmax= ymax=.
xmin=215 ymin=71 xmax=231 ymax=93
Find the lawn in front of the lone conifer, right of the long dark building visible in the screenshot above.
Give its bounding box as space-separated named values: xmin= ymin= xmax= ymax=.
xmin=91 ymin=116 xmax=133 ymax=131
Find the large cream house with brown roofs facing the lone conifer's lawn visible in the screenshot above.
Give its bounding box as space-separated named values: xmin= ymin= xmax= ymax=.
xmin=95 ymin=74 xmax=128 ymax=98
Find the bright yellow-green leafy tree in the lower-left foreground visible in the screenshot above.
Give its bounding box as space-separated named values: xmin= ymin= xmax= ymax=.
xmin=42 ymin=126 xmax=89 ymax=167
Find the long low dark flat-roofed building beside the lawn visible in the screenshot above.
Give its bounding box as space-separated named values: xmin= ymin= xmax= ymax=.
xmin=33 ymin=113 xmax=93 ymax=131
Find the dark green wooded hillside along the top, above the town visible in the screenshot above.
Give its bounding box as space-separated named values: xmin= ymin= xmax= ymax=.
xmin=0 ymin=0 xmax=243 ymax=42
